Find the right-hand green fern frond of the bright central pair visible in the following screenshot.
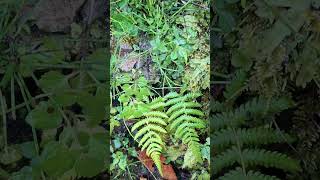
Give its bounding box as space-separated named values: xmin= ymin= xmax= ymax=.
xmin=164 ymin=92 xmax=206 ymax=166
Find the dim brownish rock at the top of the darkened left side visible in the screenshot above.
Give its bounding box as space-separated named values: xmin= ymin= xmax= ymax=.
xmin=34 ymin=0 xmax=85 ymax=32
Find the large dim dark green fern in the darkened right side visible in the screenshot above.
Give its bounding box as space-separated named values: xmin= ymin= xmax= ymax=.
xmin=211 ymin=95 xmax=300 ymax=180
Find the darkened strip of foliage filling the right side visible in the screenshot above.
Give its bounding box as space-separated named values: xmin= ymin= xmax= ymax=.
xmin=210 ymin=0 xmax=320 ymax=180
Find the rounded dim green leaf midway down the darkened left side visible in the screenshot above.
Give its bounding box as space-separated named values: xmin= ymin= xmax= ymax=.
xmin=26 ymin=101 xmax=62 ymax=130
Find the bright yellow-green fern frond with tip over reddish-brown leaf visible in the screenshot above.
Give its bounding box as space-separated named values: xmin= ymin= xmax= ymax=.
xmin=131 ymin=97 xmax=168 ymax=175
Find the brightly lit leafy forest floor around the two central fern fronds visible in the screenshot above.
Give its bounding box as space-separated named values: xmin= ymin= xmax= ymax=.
xmin=110 ymin=0 xmax=210 ymax=179
